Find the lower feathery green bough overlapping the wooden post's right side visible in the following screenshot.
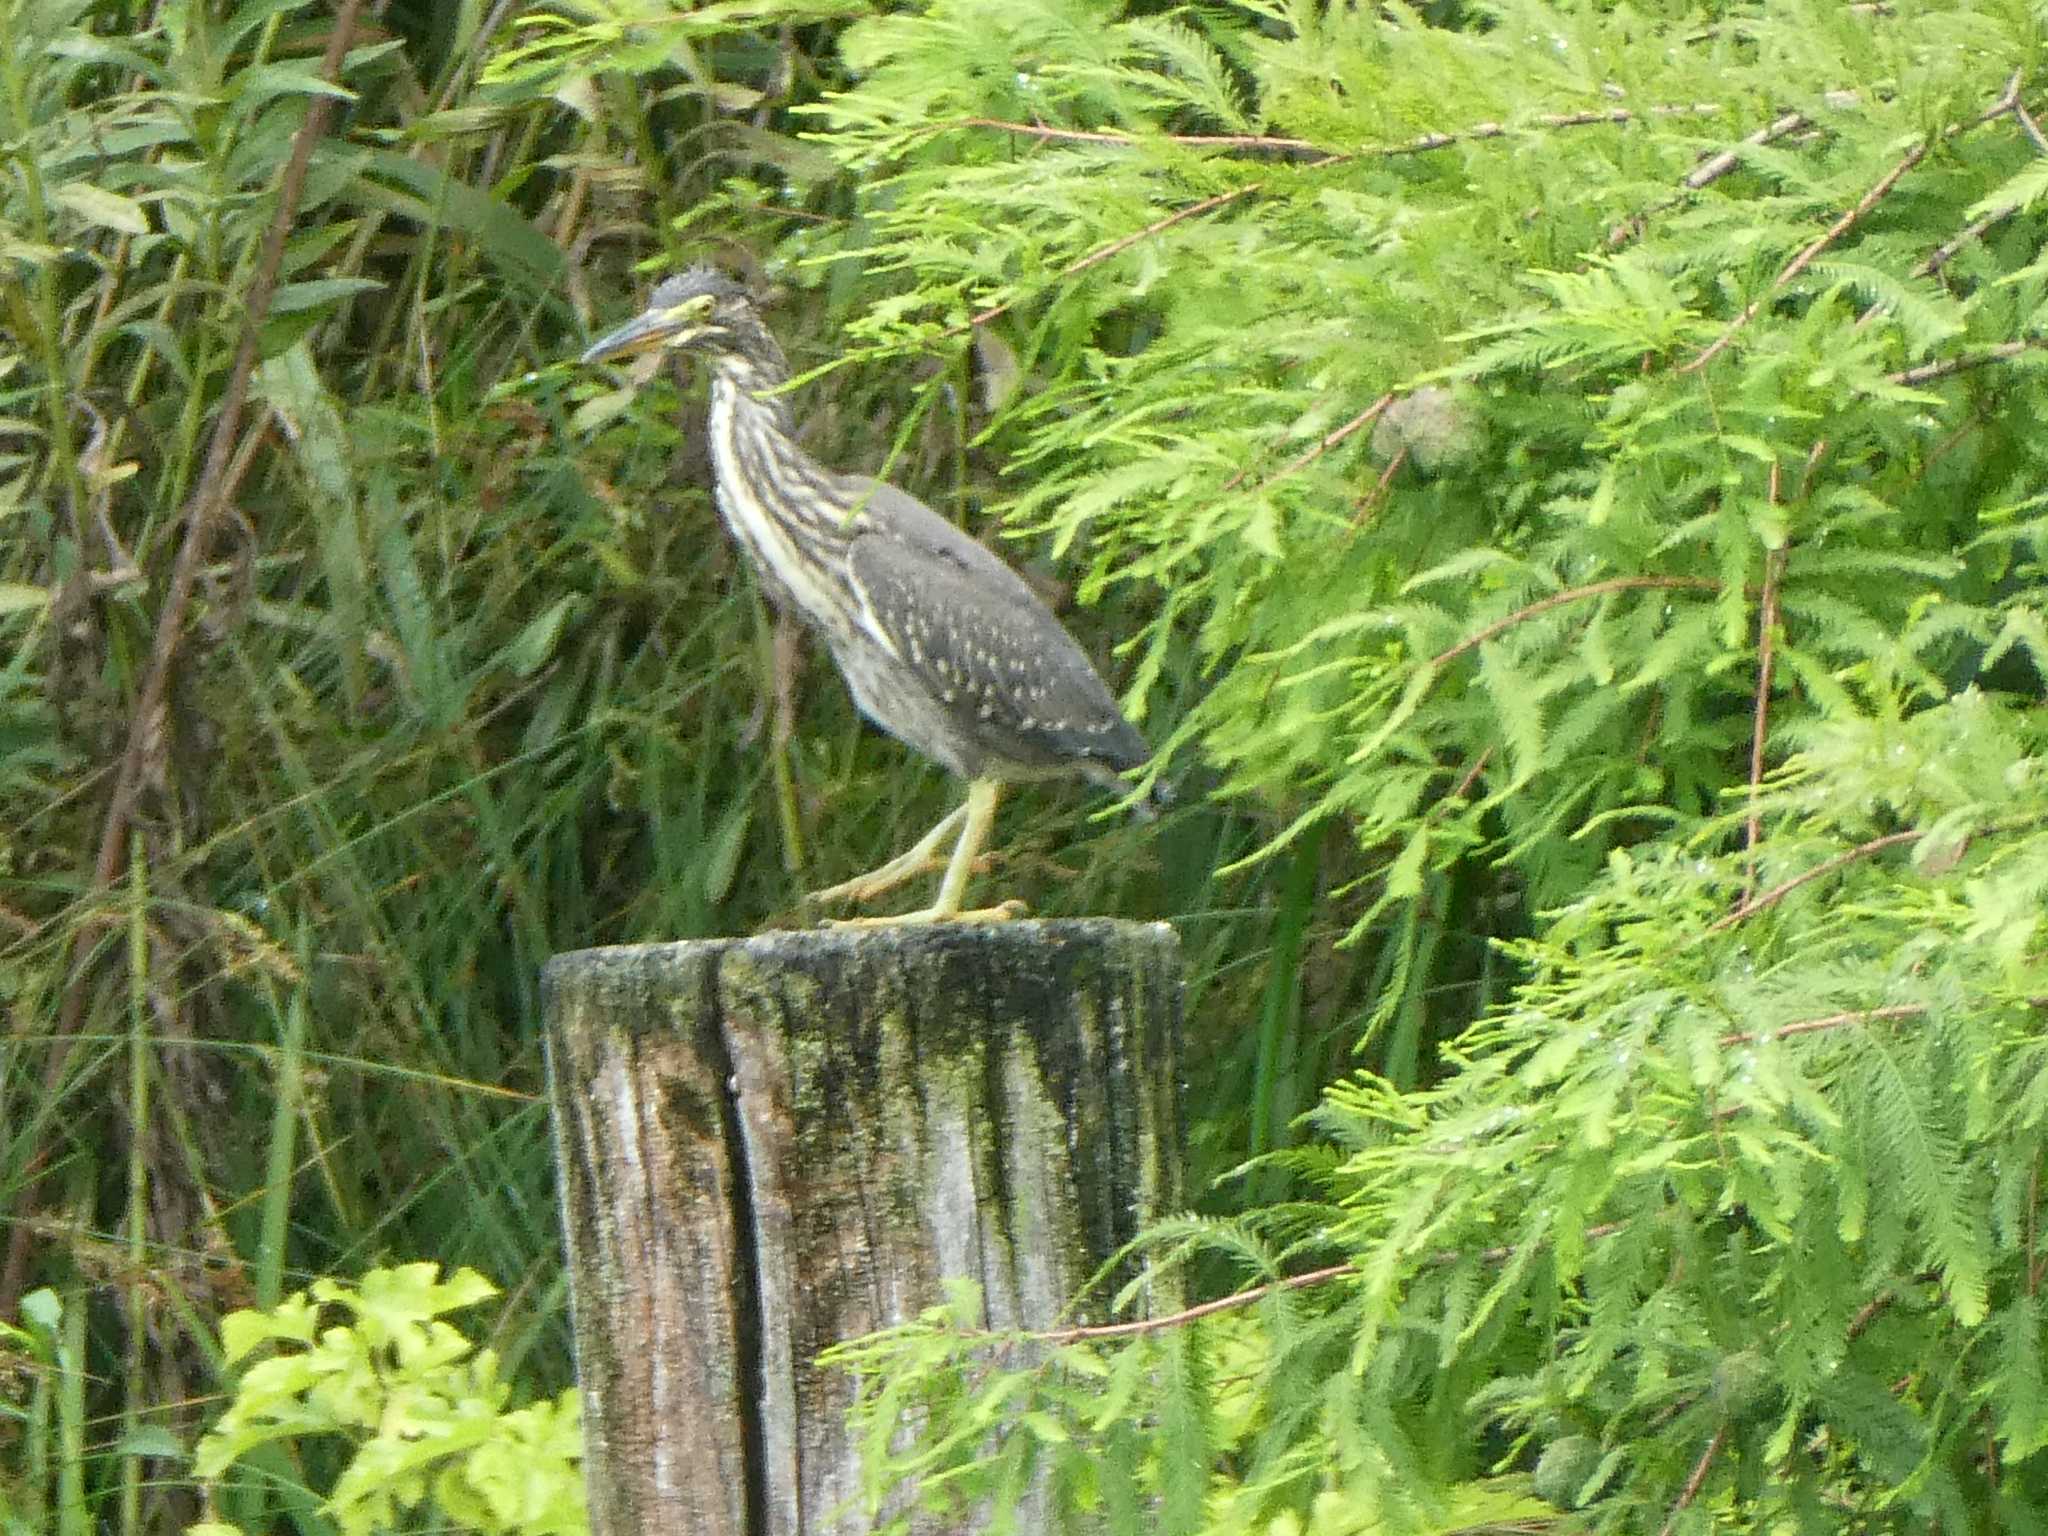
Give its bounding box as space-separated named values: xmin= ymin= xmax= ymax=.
xmin=840 ymin=704 xmax=2048 ymax=1532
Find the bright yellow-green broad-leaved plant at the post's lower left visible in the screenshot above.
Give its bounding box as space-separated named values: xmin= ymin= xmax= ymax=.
xmin=188 ymin=1264 xmax=590 ymax=1536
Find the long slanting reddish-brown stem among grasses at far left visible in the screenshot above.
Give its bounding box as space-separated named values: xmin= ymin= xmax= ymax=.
xmin=0 ymin=0 xmax=362 ymax=1317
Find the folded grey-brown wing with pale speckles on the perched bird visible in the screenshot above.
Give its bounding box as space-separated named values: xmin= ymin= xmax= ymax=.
xmin=846 ymin=485 xmax=1151 ymax=770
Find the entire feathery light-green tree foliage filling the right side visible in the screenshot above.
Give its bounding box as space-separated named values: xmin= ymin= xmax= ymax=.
xmin=778 ymin=0 xmax=2048 ymax=1532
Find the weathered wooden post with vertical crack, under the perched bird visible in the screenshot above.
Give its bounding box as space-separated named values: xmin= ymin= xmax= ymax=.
xmin=545 ymin=920 xmax=1180 ymax=1536
